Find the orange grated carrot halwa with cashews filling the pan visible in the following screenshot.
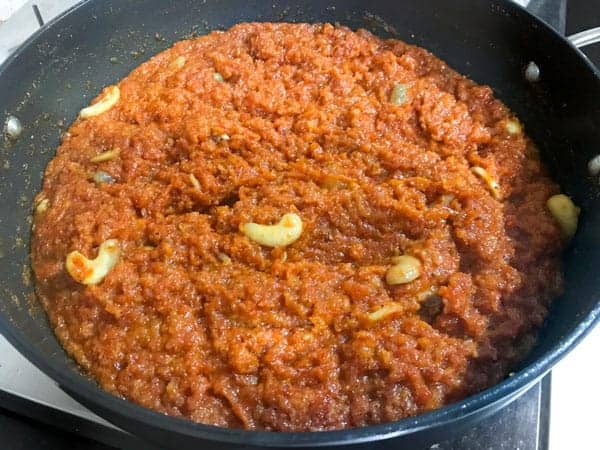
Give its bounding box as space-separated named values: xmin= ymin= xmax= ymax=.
xmin=32 ymin=23 xmax=568 ymax=431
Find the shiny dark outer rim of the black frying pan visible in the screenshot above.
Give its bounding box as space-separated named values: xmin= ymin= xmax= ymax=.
xmin=0 ymin=0 xmax=600 ymax=447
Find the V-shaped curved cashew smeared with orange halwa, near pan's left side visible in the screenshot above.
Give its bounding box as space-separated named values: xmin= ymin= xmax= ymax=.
xmin=66 ymin=239 xmax=121 ymax=284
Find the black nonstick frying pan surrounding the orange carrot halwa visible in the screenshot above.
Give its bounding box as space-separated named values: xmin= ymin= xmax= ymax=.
xmin=0 ymin=0 xmax=600 ymax=449
